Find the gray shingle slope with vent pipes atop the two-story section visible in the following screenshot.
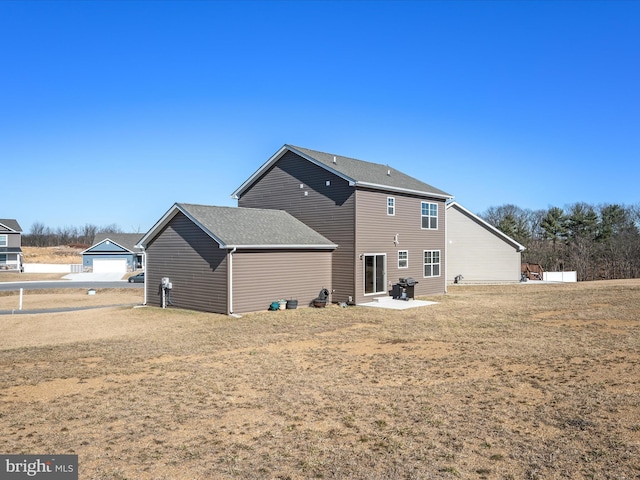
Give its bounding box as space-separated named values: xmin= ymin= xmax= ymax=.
xmin=286 ymin=145 xmax=451 ymax=197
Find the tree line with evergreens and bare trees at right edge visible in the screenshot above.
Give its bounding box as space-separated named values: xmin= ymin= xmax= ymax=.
xmin=478 ymin=202 xmax=640 ymax=281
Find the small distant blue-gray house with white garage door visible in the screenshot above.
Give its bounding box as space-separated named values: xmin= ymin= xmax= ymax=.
xmin=82 ymin=233 xmax=144 ymax=274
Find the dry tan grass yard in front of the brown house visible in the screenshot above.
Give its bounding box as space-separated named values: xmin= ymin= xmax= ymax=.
xmin=0 ymin=280 xmax=640 ymax=480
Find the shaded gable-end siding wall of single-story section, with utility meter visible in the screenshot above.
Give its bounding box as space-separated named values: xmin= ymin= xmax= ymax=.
xmin=145 ymin=213 xmax=228 ymax=314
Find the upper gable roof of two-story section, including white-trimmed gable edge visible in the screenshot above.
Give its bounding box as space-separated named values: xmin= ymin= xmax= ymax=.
xmin=231 ymin=144 xmax=453 ymax=199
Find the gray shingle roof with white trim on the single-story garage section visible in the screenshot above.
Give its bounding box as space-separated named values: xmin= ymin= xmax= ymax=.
xmin=140 ymin=203 xmax=337 ymax=249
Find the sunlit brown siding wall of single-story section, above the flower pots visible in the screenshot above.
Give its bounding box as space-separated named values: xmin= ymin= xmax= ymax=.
xmin=232 ymin=250 xmax=331 ymax=313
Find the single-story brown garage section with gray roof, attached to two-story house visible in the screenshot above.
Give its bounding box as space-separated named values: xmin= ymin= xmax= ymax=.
xmin=140 ymin=203 xmax=336 ymax=314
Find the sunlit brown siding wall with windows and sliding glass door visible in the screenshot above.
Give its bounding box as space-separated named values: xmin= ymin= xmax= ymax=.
xmin=355 ymin=189 xmax=446 ymax=303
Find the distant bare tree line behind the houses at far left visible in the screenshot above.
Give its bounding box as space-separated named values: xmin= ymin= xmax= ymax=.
xmin=22 ymin=222 xmax=123 ymax=247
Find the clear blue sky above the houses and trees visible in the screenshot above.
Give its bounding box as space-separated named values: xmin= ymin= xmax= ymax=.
xmin=0 ymin=0 xmax=640 ymax=232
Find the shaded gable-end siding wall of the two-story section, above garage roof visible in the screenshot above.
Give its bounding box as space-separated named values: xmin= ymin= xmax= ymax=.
xmin=238 ymin=152 xmax=355 ymax=302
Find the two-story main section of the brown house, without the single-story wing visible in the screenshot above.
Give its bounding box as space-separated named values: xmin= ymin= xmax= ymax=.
xmin=232 ymin=145 xmax=452 ymax=304
